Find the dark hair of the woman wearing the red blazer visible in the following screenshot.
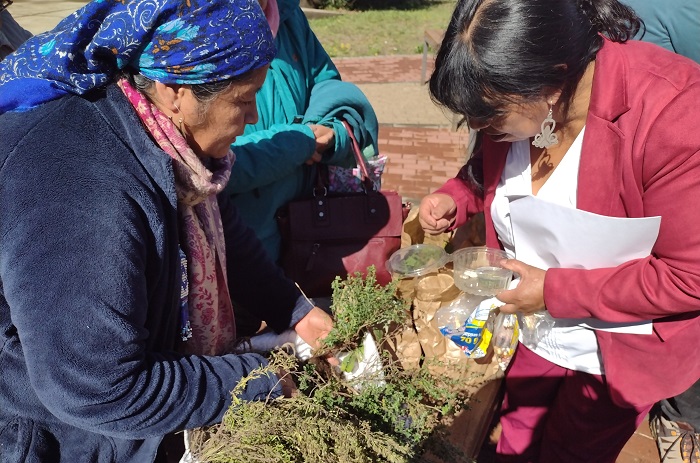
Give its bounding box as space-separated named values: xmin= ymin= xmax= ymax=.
xmin=429 ymin=0 xmax=642 ymax=126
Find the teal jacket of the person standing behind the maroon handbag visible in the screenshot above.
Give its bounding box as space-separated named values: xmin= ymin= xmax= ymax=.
xmin=225 ymin=0 xmax=378 ymax=260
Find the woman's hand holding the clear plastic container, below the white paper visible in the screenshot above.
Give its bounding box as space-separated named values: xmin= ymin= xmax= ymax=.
xmin=496 ymin=259 xmax=547 ymax=315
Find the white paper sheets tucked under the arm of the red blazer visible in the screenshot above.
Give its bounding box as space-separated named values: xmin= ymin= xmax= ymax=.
xmin=508 ymin=196 xmax=661 ymax=334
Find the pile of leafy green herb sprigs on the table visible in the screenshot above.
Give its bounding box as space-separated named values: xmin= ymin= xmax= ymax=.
xmin=192 ymin=268 xmax=471 ymax=463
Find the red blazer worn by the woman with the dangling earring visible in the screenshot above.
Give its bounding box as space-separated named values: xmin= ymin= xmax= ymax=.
xmin=438 ymin=40 xmax=700 ymax=406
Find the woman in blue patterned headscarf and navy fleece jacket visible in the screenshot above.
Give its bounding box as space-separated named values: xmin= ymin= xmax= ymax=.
xmin=0 ymin=0 xmax=331 ymax=463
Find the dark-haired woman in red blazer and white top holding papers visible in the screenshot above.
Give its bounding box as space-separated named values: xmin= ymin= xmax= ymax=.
xmin=419 ymin=0 xmax=700 ymax=463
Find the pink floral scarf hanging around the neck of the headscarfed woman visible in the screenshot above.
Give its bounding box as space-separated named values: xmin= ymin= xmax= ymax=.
xmin=118 ymin=79 xmax=236 ymax=355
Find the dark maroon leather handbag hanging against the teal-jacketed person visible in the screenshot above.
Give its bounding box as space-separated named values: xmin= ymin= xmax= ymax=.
xmin=277 ymin=122 xmax=410 ymax=297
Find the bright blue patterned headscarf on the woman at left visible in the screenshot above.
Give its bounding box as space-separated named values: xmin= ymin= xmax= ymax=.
xmin=0 ymin=0 xmax=276 ymax=114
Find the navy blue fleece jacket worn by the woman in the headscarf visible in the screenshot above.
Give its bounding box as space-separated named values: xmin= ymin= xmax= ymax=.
xmin=0 ymin=86 xmax=310 ymax=463
